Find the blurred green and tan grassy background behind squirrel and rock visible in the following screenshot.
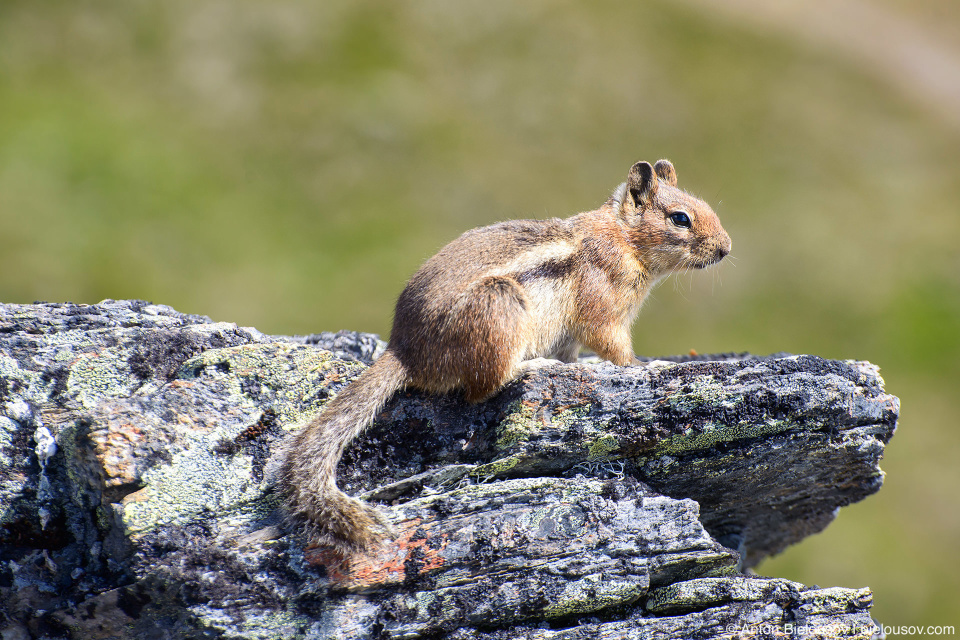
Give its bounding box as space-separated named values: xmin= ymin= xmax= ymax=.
xmin=0 ymin=0 xmax=960 ymax=625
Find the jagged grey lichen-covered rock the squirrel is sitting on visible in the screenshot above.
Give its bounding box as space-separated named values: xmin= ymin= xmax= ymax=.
xmin=0 ymin=301 xmax=899 ymax=640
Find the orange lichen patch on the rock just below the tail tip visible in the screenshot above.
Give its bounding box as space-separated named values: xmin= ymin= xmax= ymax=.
xmin=304 ymin=518 xmax=448 ymax=591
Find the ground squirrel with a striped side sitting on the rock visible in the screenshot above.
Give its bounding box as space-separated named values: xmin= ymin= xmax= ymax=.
xmin=282 ymin=160 xmax=730 ymax=555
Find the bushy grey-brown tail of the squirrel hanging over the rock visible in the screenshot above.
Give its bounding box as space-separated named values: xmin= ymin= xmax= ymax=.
xmin=282 ymin=349 xmax=408 ymax=554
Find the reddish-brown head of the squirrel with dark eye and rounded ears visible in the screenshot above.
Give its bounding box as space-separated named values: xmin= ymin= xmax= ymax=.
xmin=613 ymin=160 xmax=731 ymax=276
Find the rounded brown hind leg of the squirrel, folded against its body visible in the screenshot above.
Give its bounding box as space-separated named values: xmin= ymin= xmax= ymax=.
xmin=451 ymin=276 xmax=530 ymax=402
